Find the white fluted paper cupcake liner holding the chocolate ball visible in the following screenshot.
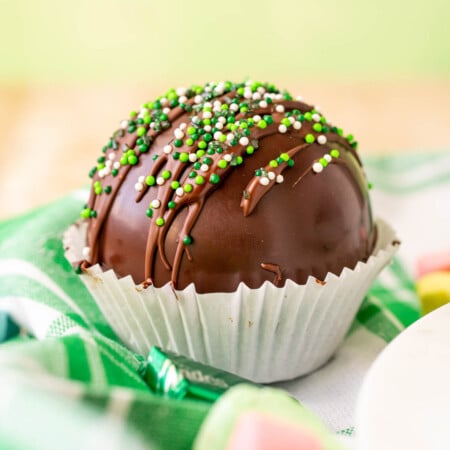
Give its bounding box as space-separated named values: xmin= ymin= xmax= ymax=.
xmin=64 ymin=220 xmax=398 ymax=383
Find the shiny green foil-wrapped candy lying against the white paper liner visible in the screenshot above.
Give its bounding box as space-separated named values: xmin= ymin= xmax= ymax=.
xmin=144 ymin=347 xmax=257 ymax=402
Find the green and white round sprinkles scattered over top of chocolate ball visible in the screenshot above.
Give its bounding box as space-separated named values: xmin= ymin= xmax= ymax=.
xmin=81 ymin=81 xmax=357 ymax=226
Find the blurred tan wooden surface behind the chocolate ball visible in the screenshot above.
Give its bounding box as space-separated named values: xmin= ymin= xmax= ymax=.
xmin=0 ymin=81 xmax=450 ymax=218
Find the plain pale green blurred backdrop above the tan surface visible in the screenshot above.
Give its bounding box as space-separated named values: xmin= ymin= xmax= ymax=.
xmin=0 ymin=0 xmax=450 ymax=85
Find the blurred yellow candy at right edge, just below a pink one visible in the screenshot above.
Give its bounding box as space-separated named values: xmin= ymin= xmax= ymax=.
xmin=416 ymin=272 xmax=450 ymax=314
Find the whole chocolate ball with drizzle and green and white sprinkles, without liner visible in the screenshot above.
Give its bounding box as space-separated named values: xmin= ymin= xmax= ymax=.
xmin=81 ymin=82 xmax=376 ymax=293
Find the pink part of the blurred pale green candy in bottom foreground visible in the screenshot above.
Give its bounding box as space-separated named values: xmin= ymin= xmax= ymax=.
xmin=227 ymin=412 xmax=324 ymax=450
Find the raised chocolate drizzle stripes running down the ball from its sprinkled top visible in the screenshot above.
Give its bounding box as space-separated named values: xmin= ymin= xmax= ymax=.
xmin=82 ymin=80 xmax=371 ymax=288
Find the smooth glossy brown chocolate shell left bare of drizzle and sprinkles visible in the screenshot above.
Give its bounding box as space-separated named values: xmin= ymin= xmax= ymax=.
xmin=87 ymin=86 xmax=376 ymax=293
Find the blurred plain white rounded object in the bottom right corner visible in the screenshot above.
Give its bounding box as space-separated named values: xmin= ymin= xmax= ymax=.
xmin=356 ymin=304 xmax=450 ymax=450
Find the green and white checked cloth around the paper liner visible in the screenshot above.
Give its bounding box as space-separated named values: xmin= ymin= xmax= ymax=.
xmin=0 ymin=154 xmax=450 ymax=450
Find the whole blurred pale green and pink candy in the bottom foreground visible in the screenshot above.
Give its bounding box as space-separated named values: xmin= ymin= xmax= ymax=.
xmin=193 ymin=384 xmax=342 ymax=450
